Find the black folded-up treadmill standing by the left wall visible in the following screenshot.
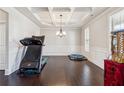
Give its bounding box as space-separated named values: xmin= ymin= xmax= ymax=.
xmin=19 ymin=36 xmax=45 ymax=74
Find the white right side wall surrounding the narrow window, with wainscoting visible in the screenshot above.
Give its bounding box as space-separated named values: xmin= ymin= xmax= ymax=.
xmin=81 ymin=8 xmax=123 ymax=69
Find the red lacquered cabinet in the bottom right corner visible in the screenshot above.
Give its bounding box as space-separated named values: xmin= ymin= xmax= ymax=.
xmin=104 ymin=60 xmax=124 ymax=86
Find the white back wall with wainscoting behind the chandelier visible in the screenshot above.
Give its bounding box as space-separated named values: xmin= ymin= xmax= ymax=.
xmin=41 ymin=28 xmax=81 ymax=55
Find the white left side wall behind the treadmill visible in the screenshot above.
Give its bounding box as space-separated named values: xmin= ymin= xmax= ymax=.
xmin=2 ymin=7 xmax=40 ymax=74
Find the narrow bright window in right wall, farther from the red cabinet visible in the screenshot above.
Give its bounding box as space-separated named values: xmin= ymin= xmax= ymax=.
xmin=84 ymin=27 xmax=90 ymax=52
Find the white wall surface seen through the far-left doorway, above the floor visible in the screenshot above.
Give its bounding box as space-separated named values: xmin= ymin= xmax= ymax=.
xmin=0 ymin=10 xmax=7 ymax=70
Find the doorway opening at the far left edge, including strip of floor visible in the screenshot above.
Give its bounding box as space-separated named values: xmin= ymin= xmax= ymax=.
xmin=0 ymin=9 xmax=8 ymax=74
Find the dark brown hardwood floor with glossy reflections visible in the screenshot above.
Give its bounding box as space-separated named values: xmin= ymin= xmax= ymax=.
xmin=0 ymin=56 xmax=104 ymax=86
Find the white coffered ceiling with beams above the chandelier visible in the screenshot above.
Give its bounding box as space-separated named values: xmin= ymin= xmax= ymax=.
xmin=16 ymin=7 xmax=107 ymax=27
